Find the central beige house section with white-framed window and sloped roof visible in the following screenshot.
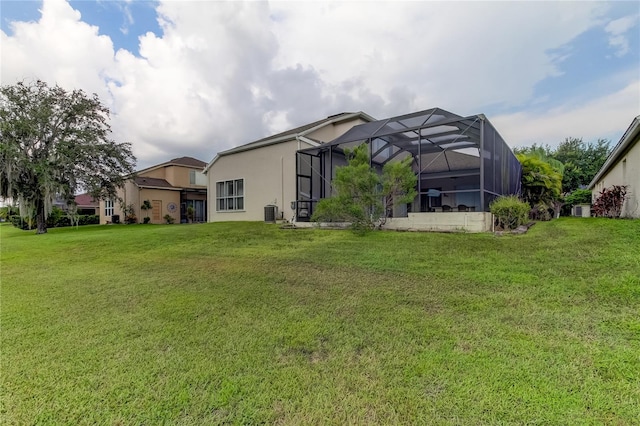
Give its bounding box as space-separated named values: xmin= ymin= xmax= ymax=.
xmin=204 ymin=112 xmax=374 ymax=222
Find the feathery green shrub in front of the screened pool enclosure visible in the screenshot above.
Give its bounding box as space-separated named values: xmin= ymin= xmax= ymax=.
xmin=311 ymin=144 xmax=416 ymax=232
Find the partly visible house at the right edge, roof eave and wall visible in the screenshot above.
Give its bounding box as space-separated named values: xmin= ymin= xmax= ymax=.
xmin=588 ymin=115 xmax=640 ymax=218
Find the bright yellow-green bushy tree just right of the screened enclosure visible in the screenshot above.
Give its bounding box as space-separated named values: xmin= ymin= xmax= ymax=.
xmin=517 ymin=154 xmax=562 ymax=220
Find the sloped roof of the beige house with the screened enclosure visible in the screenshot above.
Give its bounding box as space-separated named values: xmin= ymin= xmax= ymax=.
xmin=204 ymin=111 xmax=375 ymax=173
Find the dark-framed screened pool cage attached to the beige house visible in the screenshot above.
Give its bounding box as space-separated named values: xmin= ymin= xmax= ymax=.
xmin=292 ymin=108 xmax=521 ymax=222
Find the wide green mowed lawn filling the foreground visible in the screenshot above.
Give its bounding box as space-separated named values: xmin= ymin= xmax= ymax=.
xmin=0 ymin=218 xmax=640 ymax=425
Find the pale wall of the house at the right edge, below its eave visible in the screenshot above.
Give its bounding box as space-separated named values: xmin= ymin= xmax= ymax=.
xmin=593 ymin=136 xmax=640 ymax=218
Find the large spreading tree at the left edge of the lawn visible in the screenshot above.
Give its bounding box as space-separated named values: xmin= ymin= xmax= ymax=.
xmin=0 ymin=80 xmax=135 ymax=234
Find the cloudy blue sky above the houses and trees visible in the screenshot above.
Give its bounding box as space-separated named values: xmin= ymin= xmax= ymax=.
xmin=0 ymin=0 xmax=640 ymax=167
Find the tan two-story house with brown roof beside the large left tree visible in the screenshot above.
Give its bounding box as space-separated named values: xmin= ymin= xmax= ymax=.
xmin=100 ymin=157 xmax=207 ymax=224
